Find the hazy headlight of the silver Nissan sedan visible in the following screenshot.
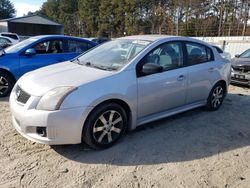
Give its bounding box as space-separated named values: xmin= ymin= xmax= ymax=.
xmin=36 ymin=87 xmax=77 ymax=111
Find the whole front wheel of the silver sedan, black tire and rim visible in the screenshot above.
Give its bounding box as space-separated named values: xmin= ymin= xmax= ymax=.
xmin=82 ymin=103 xmax=128 ymax=149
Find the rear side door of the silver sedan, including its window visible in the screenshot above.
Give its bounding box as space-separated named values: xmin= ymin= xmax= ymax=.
xmin=185 ymin=42 xmax=217 ymax=104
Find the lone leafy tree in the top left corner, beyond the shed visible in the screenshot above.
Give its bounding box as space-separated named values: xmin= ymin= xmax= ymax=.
xmin=0 ymin=0 xmax=16 ymax=19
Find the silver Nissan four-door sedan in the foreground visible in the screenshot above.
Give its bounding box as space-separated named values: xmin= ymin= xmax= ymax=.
xmin=10 ymin=35 xmax=231 ymax=149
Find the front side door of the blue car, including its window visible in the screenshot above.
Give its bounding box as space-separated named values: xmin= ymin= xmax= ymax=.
xmin=20 ymin=39 xmax=69 ymax=75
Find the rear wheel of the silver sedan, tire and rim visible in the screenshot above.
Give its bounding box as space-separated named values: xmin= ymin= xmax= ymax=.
xmin=206 ymin=82 xmax=226 ymax=111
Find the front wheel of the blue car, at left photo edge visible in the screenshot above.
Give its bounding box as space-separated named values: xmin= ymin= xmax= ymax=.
xmin=0 ymin=71 xmax=15 ymax=98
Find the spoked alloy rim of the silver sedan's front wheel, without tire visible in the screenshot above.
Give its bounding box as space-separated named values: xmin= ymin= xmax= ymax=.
xmin=93 ymin=110 xmax=124 ymax=145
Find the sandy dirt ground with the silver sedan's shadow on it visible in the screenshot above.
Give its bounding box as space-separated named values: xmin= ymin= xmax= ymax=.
xmin=0 ymin=86 xmax=250 ymax=188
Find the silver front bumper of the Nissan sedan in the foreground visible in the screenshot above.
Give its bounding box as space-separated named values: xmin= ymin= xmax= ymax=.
xmin=10 ymin=90 xmax=91 ymax=145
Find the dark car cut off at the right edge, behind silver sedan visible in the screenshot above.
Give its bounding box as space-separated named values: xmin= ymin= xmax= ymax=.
xmin=231 ymin=49 xmax=250 ymax=86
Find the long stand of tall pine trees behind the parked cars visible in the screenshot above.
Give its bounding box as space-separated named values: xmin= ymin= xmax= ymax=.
xmin=36 ymin=0 xmax=250 ymax=37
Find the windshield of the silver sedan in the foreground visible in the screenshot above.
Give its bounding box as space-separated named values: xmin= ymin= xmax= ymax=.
xmin=74 ymin=39 xmax=150 ymax=70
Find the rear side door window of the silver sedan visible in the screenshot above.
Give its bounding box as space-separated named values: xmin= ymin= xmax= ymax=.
xmin=186 ymin=42 xmax=214 ymax=65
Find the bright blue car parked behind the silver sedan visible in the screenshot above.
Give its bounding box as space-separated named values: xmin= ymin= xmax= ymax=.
xmin=0 ymin=35 xmax=96 ymax=97
